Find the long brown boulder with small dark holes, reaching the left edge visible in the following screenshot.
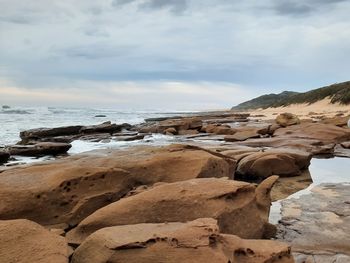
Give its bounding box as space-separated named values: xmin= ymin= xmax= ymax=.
xmin=0 ymin=145 xmax=235 ymax=225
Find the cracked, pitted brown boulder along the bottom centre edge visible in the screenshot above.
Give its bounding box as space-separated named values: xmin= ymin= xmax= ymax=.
xmin=71 ymin=218 xmax=294 ymax=263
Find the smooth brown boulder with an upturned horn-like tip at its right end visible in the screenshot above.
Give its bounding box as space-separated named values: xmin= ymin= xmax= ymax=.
xmin=67 ymin=177 xmax=278 ymax=244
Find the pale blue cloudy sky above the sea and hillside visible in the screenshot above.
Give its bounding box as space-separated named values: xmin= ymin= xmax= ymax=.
xmin=0 ymin=0 xmax=350 ymax=110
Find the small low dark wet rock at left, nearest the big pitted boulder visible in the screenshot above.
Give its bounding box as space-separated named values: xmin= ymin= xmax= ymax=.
xmin=6 ymin=142 xmax=72 ymax=156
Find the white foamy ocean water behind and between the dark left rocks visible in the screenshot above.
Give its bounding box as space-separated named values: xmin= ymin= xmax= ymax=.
xmin=0 ymin=106 xmax=194 ymax=162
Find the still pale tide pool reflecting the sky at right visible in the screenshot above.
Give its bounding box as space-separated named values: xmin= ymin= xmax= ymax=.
xmin=269 ymin=157 xmax=350 ymax=224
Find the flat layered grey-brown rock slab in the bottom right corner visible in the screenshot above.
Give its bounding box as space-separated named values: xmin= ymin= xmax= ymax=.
xmin=277 ymin=184 xmax=350 ymax=263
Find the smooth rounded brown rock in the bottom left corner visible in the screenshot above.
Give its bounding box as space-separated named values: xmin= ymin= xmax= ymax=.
xmin=0 ymin=219 xmax=68 ymax=263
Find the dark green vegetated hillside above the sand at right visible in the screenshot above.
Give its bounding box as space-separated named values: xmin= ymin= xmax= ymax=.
xmin=232 ymin=81 xmax=350 ymax=110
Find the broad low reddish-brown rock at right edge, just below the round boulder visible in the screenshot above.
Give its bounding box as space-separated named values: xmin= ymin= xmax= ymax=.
xmin=275 ymin=123 xmax=350 ymax=145
